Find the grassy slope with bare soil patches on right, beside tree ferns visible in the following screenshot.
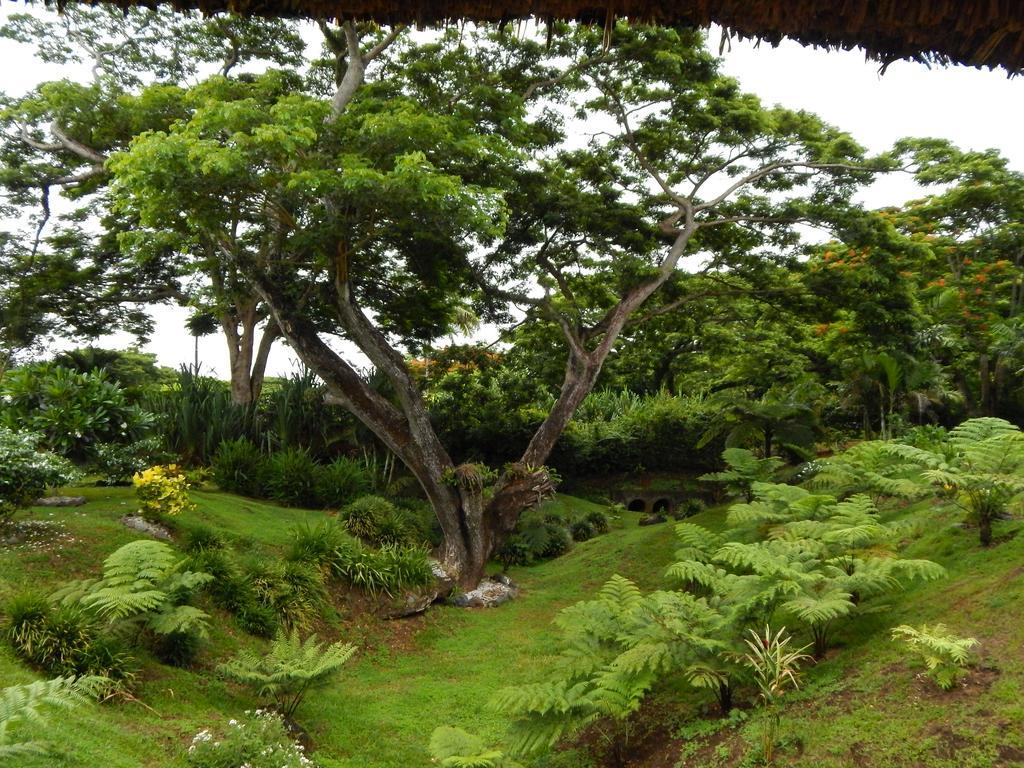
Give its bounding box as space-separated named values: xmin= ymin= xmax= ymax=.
xmin=667 ymin=502 xmax=1024 ymax=768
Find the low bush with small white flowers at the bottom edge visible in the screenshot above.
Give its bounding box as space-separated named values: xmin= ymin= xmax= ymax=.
xmin=184 ymin=710 xmax=315 ymax=768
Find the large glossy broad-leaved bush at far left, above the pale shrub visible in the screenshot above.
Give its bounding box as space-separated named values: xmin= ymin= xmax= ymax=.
xmin=0 ymin=365 xmax=154 ymax=461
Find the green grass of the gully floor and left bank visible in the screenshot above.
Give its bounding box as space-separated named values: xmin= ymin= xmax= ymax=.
xmin=0 ymin=489 xmax=675 ymax=768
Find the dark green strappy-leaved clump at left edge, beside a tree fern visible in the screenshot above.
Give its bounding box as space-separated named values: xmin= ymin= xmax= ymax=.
xmin=3 ymin=594 xmax=135 ymax=684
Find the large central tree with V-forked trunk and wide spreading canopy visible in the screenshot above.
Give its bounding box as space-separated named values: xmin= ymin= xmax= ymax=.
xmin=97 ymin=23 xmax=867 ymax=586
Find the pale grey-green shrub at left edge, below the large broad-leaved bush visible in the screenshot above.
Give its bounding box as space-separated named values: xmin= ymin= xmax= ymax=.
xmin=0 ymin=427 xmax=78 ymax=520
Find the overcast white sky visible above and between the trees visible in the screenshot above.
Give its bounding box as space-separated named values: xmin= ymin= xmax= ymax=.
xmin=0 ymin=3 xmax=1024 ymax=376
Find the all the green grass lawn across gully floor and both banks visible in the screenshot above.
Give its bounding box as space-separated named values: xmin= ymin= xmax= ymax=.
xmin=6 ymin=488 xmax=1024 ymax=768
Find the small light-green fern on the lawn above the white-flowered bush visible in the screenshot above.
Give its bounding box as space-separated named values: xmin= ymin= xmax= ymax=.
xmin=217 ymin=630 xmax=355 ymax=718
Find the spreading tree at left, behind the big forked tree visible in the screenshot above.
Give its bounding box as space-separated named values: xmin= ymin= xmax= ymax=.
xmin=0 ymin=7 xmax=303 ymax=403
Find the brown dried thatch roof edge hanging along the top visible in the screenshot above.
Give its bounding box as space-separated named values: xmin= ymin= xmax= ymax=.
xmin=28 ymin=0 xmax=1024 ymax=74
